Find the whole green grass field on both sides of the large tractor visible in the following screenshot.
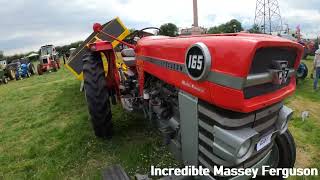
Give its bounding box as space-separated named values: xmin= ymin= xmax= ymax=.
xmin=0 ymin=57 xmax=320 ymax=179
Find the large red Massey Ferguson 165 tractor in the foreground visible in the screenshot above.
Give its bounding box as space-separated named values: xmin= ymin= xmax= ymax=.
xmin=83 ymin=24 xmax=303 ymax=178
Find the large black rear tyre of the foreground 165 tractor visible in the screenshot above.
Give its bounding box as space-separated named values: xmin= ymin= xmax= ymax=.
xmin=83 ymin=53 xmax=113 ymax=138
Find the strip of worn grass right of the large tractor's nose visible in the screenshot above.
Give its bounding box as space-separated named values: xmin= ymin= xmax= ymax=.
xmin=286 ymin=56 xmax=320 ymax=179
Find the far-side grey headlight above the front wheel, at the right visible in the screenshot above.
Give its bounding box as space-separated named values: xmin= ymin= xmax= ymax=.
xmin=276 ymin=106 xmax=293 ymax=134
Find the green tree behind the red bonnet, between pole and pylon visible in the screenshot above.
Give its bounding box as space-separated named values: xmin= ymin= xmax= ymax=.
xmin=208 ymin=19 xmax=243 ymax=34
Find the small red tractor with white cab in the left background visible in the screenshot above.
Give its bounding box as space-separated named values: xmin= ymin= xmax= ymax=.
xmin=37 ymin=45 xmax=60 ymax=75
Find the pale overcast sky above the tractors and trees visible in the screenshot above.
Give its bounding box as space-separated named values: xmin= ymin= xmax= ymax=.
xmin=0 ymin=0 xmax=320 ymax=55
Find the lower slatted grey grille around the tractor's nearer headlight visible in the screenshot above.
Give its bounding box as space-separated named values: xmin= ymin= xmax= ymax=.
xmin=198 ymin=101 xmax=282 ymax=179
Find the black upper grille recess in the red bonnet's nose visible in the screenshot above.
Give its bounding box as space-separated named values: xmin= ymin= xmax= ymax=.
xmin=244 ymin=48 xmax=297 ymax=99
